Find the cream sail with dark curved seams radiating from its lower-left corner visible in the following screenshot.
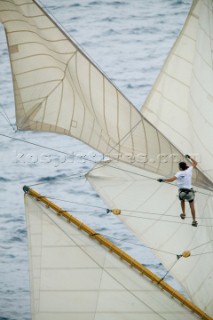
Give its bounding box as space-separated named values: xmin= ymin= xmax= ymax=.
xmin=0 ymin=0 xmax=211 ymax=186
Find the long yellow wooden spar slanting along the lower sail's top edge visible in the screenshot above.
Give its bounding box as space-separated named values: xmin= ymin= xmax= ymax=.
xmin=23 ymin=186 xmax=213 ymax=320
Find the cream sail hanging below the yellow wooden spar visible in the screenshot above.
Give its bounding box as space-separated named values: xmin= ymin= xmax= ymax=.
xmin=25 ymin=195 xmax=203 ymax=320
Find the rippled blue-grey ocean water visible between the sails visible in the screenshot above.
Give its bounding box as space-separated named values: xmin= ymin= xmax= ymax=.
xmin=0 ymin=0 xmax=191 ymax=320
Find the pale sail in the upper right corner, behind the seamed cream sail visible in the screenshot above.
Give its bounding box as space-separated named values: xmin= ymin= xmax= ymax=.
xmin=141 ymin=0 xmax=213 ymax=181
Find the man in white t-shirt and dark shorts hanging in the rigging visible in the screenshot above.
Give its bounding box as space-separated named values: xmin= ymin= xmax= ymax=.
xmin=158 ymin=155 xmax=198 ymax=227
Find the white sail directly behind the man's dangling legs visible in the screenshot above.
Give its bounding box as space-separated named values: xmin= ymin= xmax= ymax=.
xmin=87 ymin=161 xmax=213 ymax=316
